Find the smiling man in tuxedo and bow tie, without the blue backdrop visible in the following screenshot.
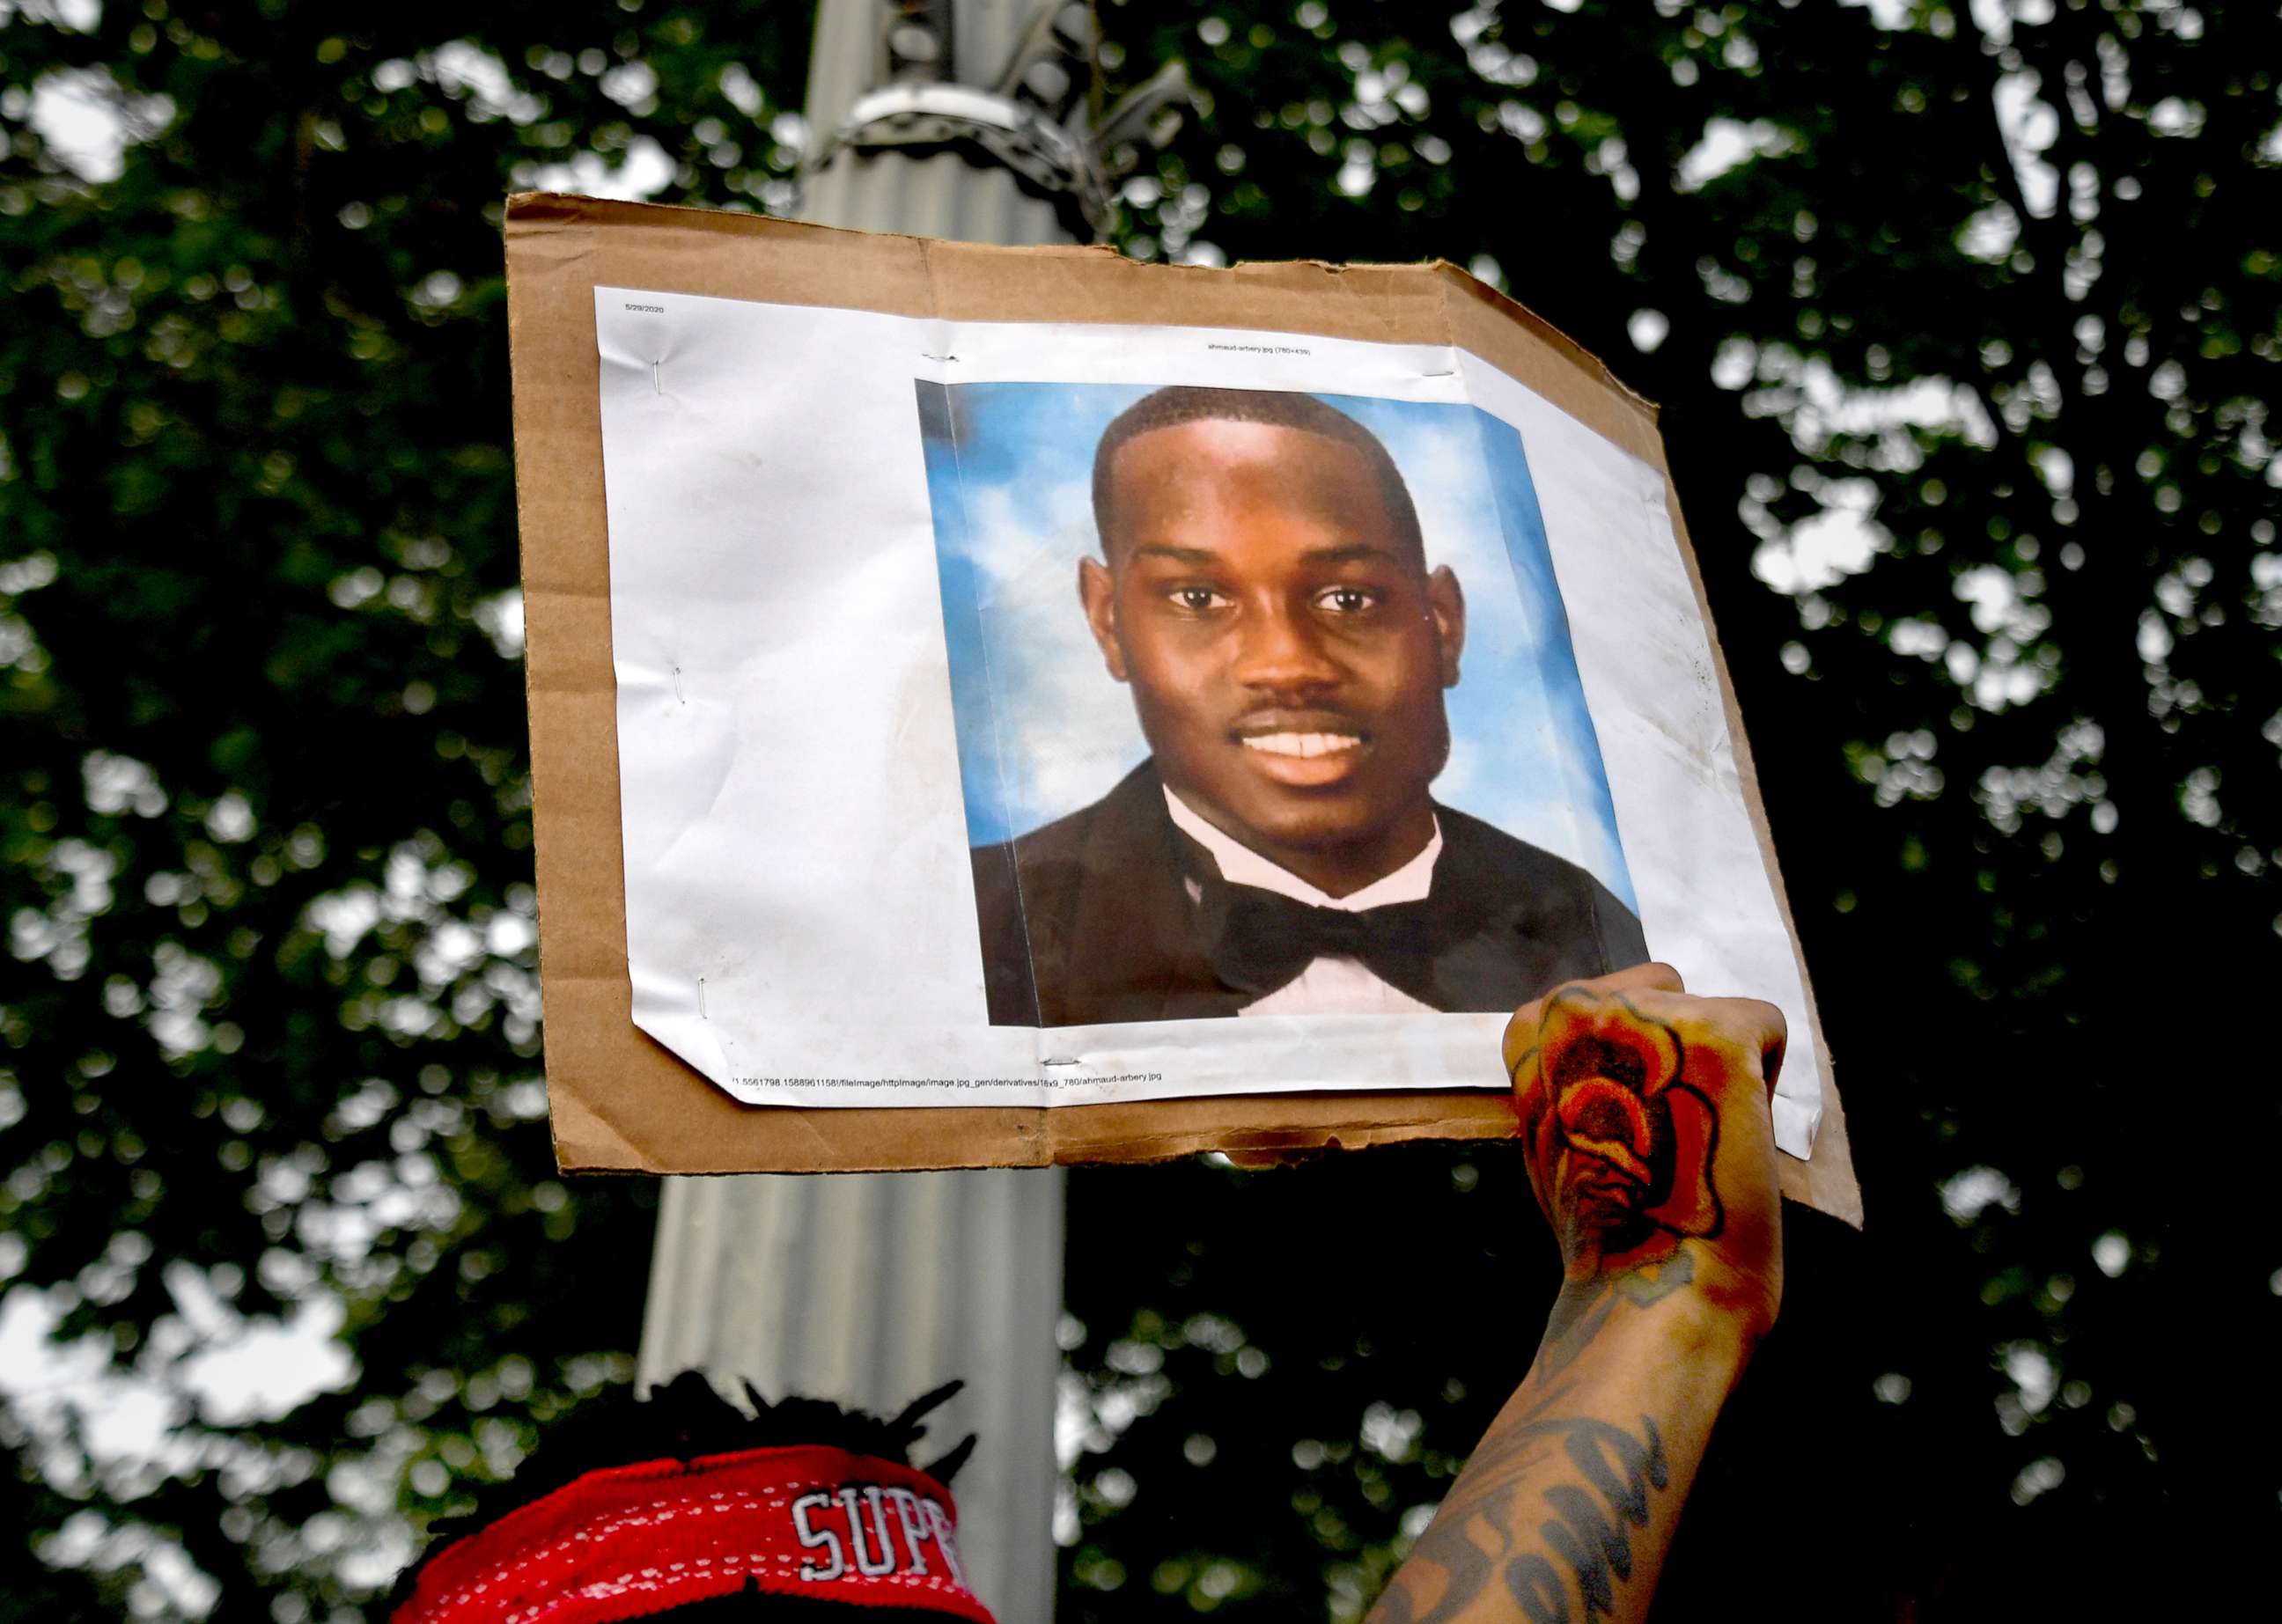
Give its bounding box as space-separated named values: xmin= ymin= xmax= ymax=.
xmin=975 ymin=388 xmax=1647 ymax=1026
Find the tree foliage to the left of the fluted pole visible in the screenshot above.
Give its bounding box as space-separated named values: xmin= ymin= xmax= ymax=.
xmin=0 ymin=0 xmax=806 ymax=1621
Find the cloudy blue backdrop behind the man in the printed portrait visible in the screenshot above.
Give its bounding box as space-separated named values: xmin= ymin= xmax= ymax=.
xmin=917 ymin=383 xmax=1638 ymax=910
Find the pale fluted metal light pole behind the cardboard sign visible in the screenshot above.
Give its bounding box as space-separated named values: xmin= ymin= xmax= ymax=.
xmin=641 ymin=0 xmax=1187 ymax=1624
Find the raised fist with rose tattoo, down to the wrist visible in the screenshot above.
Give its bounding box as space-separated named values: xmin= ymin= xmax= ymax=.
xmin=1506 ymin=965 xmax=1785 ymax=1341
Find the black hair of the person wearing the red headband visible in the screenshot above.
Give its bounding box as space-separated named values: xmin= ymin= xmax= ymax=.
xmin=379 ymin=1370 xmax=975 ymax=1624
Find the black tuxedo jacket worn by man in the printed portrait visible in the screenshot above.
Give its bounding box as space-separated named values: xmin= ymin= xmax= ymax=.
xmin=972 ymin=761 xmax=1647 ymax=1026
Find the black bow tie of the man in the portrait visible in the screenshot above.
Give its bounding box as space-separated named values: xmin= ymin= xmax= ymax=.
xmin=1198 ymin=878 xmax=1442 ymax=1003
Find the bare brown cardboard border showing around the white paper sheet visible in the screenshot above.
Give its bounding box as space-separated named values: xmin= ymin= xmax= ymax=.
xmin=506 ymin=194 xmax=1862 ymax=1225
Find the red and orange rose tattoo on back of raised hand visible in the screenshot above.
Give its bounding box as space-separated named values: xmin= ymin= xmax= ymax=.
xmin=1513 ymin=988 xmax=1726 ymax=1280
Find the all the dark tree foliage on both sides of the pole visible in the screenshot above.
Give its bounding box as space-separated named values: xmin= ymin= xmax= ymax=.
xmin=0 ymin=0 xmax=2282 ymax=1621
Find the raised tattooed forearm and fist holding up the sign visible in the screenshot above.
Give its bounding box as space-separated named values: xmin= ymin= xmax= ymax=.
xmin=1369 ymin=965 xmax=1782 ymax=1624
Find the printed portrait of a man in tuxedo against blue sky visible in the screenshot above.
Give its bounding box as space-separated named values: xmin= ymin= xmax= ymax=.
xmin=917 ymin=381 xmax=1647 ymax=1026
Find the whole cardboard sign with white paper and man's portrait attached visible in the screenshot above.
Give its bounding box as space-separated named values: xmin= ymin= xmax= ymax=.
xmin=506 ymin=196 xmax=1859 ymax=1223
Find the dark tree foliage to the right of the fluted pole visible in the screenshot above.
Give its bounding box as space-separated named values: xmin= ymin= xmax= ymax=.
xmin=1065 ymin=0 xmax=2282 ymax=1620
